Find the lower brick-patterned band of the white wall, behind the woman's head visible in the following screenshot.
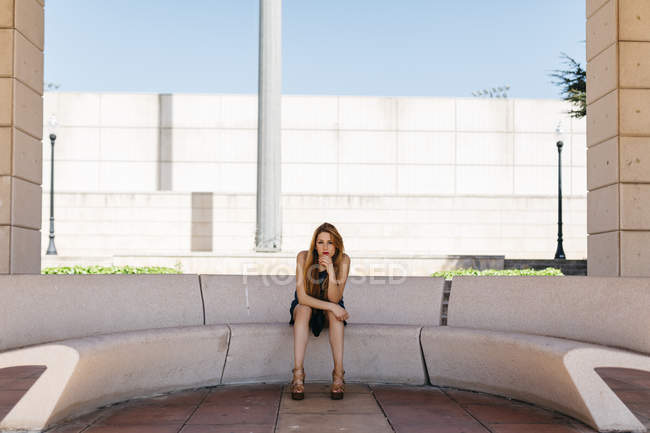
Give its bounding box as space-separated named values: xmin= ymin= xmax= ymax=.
xmin=42 ymin=192 xmax=587 ymax=259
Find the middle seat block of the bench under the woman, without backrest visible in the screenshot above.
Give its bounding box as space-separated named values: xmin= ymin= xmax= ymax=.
xmin=223 ymin=323 xmax=427 ymax=385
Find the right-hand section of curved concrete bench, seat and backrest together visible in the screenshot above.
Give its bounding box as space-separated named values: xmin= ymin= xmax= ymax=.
xmin=421 ymin=277 xmax=650 ymax=432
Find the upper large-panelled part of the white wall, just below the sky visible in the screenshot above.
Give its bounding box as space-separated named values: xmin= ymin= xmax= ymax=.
xmin=43 ymin=92 xmax=586 ymax=195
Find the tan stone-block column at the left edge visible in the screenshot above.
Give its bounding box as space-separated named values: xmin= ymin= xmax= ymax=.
xmin=0 ymin=0 xmax=44 ymax=274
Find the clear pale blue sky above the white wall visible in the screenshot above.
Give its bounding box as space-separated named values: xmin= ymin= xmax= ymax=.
xmin=45 ymin=0 xmax=585 ymax=98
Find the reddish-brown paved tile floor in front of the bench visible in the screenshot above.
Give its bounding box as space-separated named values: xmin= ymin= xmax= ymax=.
xmin=0 ymin=367 xmax=650 ymax=433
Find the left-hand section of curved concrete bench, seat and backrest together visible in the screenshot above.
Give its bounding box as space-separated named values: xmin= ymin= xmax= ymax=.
xmin=0 ymin=275 xmax=229 ymax=431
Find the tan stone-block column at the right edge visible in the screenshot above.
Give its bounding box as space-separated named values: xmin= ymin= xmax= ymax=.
xmin=587 ymin=0 xmax=650 ymax=276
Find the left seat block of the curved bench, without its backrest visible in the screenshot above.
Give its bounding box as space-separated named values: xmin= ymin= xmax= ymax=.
xmin=0 ymin=325 xmax=229 ymax=431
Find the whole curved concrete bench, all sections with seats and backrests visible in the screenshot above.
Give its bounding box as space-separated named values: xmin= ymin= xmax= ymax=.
xmin=7 ymin=275 xmax=650 ymax=432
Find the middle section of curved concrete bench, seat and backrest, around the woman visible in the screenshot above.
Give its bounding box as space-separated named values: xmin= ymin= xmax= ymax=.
xmin=201 ymin=275 xmax=444 ymax=385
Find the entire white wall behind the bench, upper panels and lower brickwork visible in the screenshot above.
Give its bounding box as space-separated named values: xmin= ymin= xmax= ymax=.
xmin=43 ymin=92 xmax=586 ymax=258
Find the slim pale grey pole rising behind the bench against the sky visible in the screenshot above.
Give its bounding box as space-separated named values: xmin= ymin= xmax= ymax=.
xmin=255 ymin=0 xmax=282 ymax=251
